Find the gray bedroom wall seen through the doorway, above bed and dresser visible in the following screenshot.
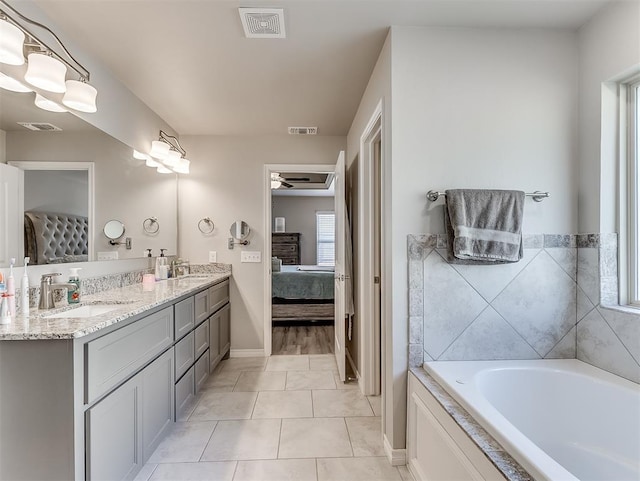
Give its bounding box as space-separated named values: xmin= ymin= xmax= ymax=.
xmin=271 ymin=195 xmax=334 ymax=265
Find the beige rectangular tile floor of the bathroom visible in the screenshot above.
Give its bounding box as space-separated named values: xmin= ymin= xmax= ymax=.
xmin=136 ymin=354 xmax=413 ymax=481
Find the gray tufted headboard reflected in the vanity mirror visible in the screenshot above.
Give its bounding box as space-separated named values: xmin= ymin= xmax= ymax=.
xmin=24 ymin=212 xmax=89 ymax=264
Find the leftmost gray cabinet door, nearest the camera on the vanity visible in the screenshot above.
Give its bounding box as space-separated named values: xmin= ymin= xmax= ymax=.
xmin=86 ymin=376 xmax=144 ymax=481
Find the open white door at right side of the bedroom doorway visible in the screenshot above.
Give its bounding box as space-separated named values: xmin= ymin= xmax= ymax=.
xmin=334 ymin=151 xmax=347 ymax=382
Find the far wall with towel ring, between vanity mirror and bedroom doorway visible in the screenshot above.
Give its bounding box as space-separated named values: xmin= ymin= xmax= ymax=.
xmin=178 ymin=136 xmax=345 ymax=350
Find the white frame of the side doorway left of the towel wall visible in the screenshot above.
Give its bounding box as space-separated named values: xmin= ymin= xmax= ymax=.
xmin=357 ymin=100 xmax=385 ymax=395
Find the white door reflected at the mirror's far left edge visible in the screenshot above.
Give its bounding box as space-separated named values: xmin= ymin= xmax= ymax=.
xmin=0 ymin=163 xmax=24 ymax=266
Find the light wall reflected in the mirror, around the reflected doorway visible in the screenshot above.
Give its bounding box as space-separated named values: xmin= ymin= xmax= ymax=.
xmin=7 ymin=131 xmax=178 ymax=259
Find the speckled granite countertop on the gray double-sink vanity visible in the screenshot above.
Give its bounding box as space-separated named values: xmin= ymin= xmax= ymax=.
xmin=0 ymin=273 xmax=231 ymax=341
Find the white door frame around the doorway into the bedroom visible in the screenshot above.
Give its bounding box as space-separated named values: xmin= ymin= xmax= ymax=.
xmin=262 ymin=164 xmax=338 ymax=356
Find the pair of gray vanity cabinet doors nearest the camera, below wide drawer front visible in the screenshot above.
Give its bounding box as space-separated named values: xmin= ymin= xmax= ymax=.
xmin=85 ymin=350 xmax=174 ymax=481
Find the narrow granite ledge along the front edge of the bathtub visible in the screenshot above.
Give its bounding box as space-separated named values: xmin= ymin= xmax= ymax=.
xmin=409 ymin=367 xmax=533 ymax=481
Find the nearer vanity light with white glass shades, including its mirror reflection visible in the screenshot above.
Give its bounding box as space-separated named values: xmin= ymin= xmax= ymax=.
xmin=0 ymin=0 xmax=98 ymax=113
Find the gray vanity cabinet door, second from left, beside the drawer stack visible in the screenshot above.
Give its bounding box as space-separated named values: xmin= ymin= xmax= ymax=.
xmin=140 ymin=349 xmax=174 ymax=463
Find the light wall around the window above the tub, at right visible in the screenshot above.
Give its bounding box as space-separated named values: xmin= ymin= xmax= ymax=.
xmin=578 ymin=2 xmax=640 ymax=233
